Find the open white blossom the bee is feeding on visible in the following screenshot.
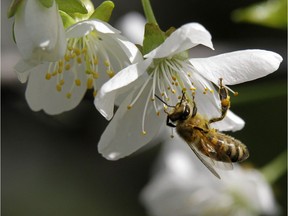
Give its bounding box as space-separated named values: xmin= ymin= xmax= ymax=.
xmin=95 ymin=23 xmax=282 ymax=160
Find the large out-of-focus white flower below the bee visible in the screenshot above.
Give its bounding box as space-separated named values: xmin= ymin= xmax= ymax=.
xmin=141 ymin=137 xmax=279 ymax=216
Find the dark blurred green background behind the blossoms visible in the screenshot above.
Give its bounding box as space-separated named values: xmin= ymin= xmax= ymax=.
xmin=1 ymin=0 xmax=287 ymax=216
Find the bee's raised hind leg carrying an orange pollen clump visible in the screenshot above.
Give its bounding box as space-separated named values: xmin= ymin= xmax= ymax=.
xmin=209 ymin=78 xmax=230 ymax=123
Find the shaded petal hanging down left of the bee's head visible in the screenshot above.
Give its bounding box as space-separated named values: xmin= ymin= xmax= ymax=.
xmin=98 ymin=85 xmax=166 ymax=160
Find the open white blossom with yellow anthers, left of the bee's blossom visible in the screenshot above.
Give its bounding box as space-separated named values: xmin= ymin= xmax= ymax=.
xmin=15 ymin=19 xmax=142 ymax=114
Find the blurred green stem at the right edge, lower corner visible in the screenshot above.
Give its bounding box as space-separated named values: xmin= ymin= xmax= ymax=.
xmin=261 ymin=151 xmax=287 ymax=184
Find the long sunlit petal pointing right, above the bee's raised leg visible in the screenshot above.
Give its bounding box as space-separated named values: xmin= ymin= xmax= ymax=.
xmin=190 ymin=50 xmax=282 ymax=85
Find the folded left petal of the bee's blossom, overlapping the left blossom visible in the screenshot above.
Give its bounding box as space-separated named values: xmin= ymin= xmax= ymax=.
xmin=94 ymin=59 xmax=152 ymax=120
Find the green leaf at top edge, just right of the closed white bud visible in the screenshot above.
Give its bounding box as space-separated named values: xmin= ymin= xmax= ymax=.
xmin=56 ymin=0 xmax=88 ymax=15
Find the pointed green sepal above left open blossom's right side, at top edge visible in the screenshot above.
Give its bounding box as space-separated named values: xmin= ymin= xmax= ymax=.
xmin=89 ymin=1 xmax=115 ymax=22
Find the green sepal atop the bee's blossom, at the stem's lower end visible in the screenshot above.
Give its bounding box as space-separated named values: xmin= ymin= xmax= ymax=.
xmin=142 ymin=23 xmax=167 ymax=55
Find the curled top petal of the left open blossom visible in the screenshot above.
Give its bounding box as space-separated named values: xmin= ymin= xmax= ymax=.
xmin=66 ymin=19 xmax=120 ymax=38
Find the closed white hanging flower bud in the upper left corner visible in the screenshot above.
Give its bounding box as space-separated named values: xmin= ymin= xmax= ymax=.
xmin=14 ymin=0 xmax=66 ymax=64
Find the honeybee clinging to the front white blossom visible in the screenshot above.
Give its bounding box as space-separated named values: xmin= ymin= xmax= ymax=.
xmin=156 ymin=79 xmax=249 ymax=179
